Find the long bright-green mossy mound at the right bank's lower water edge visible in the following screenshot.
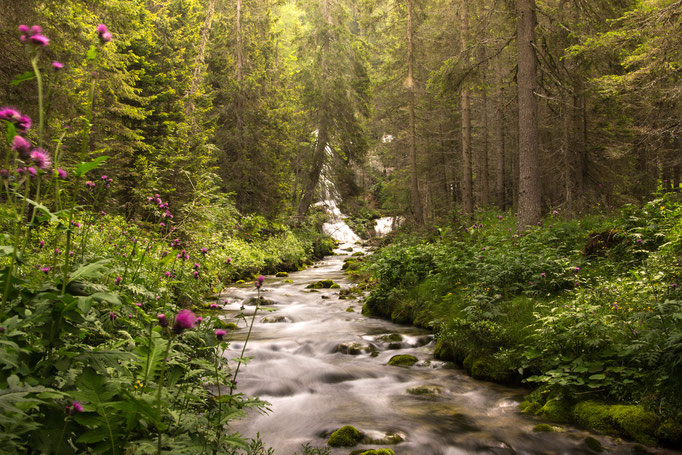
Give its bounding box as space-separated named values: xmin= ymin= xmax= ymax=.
xmin=573 ymin=401 xmax=658 ymax=445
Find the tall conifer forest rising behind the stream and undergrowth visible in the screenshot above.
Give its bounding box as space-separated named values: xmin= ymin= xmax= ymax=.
xmin=0 ymin=0 xmax=682 ymax=223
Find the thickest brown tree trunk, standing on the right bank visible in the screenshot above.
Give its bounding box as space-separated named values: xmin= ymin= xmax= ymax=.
xmin=516 ymin=0 xmax=542 ymax=230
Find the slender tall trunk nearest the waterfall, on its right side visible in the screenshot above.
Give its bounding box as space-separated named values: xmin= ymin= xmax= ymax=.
xmin=406 ymin=0 xmax=424 ymax=225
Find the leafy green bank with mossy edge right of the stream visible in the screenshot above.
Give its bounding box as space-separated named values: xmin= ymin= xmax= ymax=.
xmin=354 ymin=196 xmax=682 ymax=447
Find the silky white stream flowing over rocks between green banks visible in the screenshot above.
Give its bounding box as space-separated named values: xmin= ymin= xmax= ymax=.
xmin=225 ymin=240 xmax=666 ymax=455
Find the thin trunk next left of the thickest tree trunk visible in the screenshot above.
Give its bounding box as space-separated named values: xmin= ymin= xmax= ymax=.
xmin=459 ymin=0 xmax=474 ymax=213
